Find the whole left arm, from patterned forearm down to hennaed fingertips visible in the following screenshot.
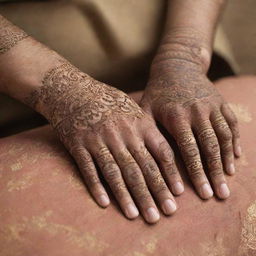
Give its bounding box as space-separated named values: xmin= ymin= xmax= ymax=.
xmin=0 ymin=16 xmax=180 ymax=223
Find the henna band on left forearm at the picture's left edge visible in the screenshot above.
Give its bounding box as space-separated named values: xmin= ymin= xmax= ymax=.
xmin=0 ymin=15 xmax=28 ymax=54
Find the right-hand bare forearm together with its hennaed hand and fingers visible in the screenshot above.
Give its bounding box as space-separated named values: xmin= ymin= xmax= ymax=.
xmin=140 ymin=0 xmax=241 ymax=199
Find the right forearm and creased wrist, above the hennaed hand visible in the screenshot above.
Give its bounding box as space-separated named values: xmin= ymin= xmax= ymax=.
xmin=152 ymin=0 xmax=225 ymax=72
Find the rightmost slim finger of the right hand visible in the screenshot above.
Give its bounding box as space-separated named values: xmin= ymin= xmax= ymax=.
xmin=221 ymin=103 xmax=242 ymax=157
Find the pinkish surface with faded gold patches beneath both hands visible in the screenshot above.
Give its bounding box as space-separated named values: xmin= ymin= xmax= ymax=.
xmin=0 ymin=77 xmax=256 ymax=256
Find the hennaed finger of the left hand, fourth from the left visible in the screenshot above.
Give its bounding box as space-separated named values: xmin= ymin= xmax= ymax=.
xmin=128 ymin=141 xmax=177 ymax=217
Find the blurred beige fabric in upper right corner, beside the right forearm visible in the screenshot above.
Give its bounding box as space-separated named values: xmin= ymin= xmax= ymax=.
xmin=215 ymin=0 xmax=256 ymax=74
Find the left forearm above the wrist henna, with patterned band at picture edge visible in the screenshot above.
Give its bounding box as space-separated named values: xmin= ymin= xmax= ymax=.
xmin=0 ymin=16 xmax=81 ymax=115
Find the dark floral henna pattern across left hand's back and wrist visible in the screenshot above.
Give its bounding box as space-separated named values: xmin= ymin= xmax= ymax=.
xmin=26 ymin=63 xmax=143 ymax=143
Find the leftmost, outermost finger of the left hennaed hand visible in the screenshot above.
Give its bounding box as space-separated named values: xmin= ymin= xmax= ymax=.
xmin=72 ymin=146 xmax=110 ymax=207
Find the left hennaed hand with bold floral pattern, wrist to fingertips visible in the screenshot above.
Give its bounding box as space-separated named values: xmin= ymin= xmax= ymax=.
xmin=32 ymin=61 xmax=183 ymax=223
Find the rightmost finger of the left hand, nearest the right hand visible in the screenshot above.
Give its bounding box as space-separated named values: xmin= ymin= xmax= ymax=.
xmin=144 ymin=131 xmax=184 ymax=195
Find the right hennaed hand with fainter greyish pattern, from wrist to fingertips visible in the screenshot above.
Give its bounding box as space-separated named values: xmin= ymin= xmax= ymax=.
xmin=141 ymin=56 xmax=241 ymax=199
